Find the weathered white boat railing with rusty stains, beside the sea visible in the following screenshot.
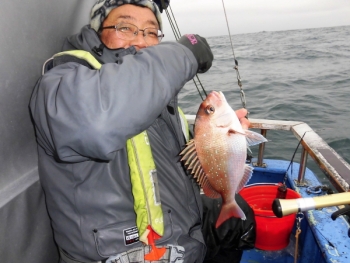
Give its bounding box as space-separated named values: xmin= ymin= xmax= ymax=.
xmin=186 ymin=115 xmax=350 ymax=192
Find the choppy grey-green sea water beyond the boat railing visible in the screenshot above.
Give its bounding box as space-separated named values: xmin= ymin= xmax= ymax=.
xmin=179 ymin=26 xmax=350 ymax=186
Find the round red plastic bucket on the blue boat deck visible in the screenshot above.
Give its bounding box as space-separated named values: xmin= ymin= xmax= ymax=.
xmin=239 ymin=185 xmax=301 ymax=250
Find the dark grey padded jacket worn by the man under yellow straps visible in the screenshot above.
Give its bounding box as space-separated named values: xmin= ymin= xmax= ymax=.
xmin=30 ymin=26 xmax=205 ymax=263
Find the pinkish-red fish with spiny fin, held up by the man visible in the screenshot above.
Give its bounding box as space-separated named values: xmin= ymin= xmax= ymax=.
xmin=180 ymin=91 xmax=267 ymax=228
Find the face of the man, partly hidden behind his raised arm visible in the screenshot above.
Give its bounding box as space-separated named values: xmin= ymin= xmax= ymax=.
xmin=100 ymin=4 xmax=159 ymax=50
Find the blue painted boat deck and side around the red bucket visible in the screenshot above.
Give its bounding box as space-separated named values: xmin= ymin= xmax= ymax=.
xmin=241 ymin=159 xmax=350 ymax=263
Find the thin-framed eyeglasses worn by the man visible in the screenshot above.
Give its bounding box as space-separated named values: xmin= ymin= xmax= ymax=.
xmin=101 ymin=22 xmax=164 ymax=45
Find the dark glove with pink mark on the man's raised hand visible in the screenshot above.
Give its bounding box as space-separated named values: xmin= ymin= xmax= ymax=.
xmin=178 ymin=34 xmax=214 ymax=73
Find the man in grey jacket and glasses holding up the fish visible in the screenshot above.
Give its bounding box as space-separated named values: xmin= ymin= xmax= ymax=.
xmin=30 ymin=0 xmax=249 ymax=263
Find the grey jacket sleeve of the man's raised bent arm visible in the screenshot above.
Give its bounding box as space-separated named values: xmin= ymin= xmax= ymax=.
xmin=29 ymin=42 xmax=197 ymax=162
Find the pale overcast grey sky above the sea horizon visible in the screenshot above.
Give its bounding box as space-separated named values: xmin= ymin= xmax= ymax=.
xmin=162 ymin=0 xmax=350 ymax=40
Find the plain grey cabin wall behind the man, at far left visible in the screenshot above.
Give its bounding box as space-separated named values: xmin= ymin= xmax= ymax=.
xmin=0 ymin=0 xmax=95 ymax=263
